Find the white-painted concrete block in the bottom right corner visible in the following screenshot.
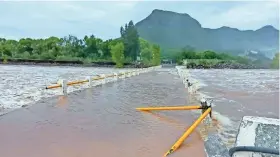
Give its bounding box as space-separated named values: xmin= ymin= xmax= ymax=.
xmin=233 ymin=116 xmax=280 ymax=157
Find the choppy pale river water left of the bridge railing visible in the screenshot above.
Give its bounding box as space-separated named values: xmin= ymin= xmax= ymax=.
xmin=0 ymin=65 xmax=136 ymax=113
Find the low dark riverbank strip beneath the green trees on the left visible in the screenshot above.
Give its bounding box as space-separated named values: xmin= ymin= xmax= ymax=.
xmin=0 ymin=59 xmax=149 ymax=68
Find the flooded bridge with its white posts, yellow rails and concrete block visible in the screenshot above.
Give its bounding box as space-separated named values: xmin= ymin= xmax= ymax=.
xmin=0 ymin=64 xmax=279 ymax=157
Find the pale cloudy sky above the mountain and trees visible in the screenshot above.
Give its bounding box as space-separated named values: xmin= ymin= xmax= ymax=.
xmin=0 ymin=0 xmax=279 ymax=39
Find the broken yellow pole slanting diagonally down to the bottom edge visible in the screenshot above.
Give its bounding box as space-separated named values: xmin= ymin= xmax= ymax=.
xmin=164 ymin=108 xmax=211 ymax=157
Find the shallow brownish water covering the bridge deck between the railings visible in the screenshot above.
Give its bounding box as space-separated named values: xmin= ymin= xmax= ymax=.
xmin=0 ymin=69 xmax=206 ymax=157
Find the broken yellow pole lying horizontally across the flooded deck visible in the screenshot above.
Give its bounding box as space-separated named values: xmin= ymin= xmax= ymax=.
xmin=136 ymin=106 xmax=202 ymax=111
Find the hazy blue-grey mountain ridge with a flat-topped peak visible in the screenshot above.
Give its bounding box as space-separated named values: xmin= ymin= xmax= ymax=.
xmin=135 ymin=9 xmax=279 ymax=58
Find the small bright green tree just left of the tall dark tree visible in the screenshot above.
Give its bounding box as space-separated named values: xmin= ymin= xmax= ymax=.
xmin=111 ymin=42 xmax=124 ymax=68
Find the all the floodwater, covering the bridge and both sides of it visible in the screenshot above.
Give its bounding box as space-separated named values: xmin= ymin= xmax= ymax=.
xmin=0 ymin=66 xmax=279 ymax=157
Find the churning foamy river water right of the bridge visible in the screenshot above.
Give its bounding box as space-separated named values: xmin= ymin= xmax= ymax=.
xmin=177 ymin=67 xmax=279 ymax=150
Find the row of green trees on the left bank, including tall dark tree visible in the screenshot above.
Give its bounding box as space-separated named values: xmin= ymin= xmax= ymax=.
xmin=0 ymin=21 xmax=160 ymax=67
